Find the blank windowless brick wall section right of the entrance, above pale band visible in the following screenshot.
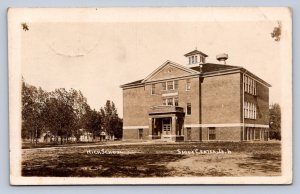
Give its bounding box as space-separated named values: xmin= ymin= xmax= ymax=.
xmin=201 ymin=73 xmax=241 ymax=124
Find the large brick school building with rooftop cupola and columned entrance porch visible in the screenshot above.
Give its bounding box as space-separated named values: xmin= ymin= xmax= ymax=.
xmin=121 ymin=50 xmax=271 ymax=141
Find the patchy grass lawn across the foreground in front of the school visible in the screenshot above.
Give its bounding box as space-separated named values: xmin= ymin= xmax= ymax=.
xmin=22 ymin=142 xmax=281 ymax=177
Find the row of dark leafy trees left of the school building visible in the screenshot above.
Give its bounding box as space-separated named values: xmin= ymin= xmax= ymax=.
xmin=22 ymin=80 xmax=123 ymax=144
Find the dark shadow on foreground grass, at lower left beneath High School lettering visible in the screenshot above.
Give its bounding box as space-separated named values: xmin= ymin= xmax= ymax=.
xmin=22 ymin=154 xmax=185 ymax=177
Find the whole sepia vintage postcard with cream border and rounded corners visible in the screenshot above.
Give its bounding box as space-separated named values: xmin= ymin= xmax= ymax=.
xmin=7 ymin=7 xmax=292 ymax=185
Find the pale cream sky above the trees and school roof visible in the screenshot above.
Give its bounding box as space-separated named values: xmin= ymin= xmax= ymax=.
xmin=21 ymin=20 xmax=284 ymax=117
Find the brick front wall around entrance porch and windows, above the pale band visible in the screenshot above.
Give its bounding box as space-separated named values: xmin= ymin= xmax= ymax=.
xmin=123 ymin=78 xmax=199 ymax=130
